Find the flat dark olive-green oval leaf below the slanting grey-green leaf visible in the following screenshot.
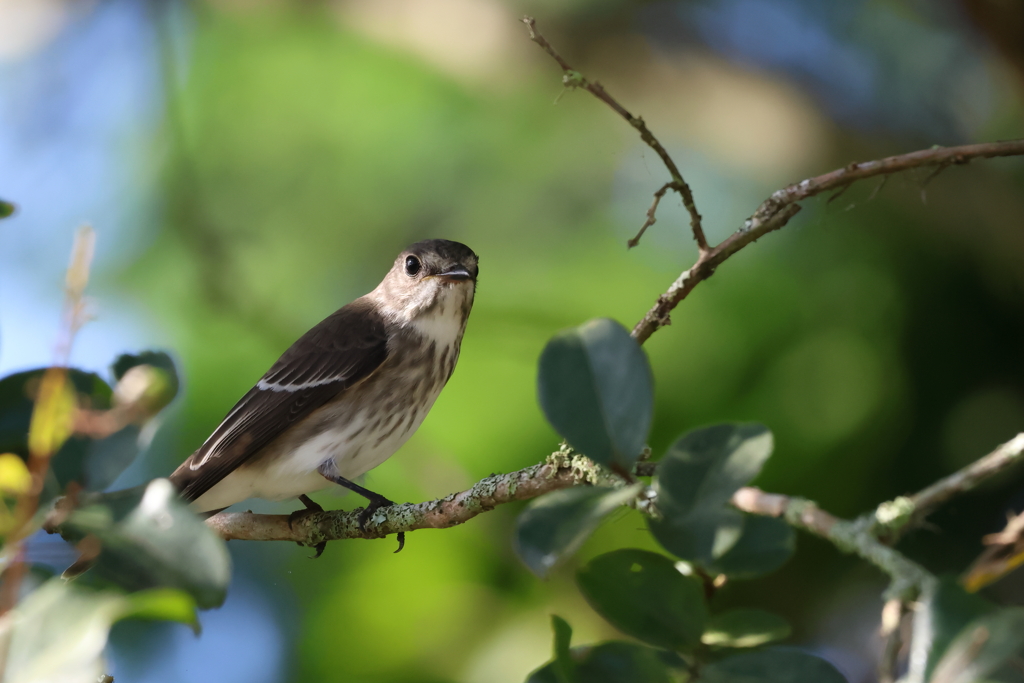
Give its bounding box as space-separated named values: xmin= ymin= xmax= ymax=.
xmin=577 ymin=549 xmax=708 ymax=651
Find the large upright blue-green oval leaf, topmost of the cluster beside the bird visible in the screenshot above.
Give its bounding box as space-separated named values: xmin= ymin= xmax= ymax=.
xmin=538 ymin=318 xmax=654 ymax=470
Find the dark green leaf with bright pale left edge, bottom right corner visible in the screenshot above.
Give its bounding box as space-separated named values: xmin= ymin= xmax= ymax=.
xmin=907 ymin=577 xmax=996 ymax=683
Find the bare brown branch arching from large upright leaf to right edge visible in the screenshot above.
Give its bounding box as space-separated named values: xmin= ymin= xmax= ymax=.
xmin=633 ymin=140 xmax=1024 ymax=344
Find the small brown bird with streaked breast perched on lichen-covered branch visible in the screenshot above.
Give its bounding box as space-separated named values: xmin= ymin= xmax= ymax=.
xmin=169 ymin=240 xmax=479 ymax=557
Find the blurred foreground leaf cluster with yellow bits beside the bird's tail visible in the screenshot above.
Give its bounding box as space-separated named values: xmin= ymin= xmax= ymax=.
xmin=0 ymin=351 xmax=230 ymax=680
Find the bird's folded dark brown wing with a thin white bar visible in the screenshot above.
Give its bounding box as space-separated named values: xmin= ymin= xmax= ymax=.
xmin=170 ymin=300 xmax=387 ymax=502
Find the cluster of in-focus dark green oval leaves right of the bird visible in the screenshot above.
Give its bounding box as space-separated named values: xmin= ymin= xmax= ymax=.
xmin=515 ymin=319 xmax=823 ymax=683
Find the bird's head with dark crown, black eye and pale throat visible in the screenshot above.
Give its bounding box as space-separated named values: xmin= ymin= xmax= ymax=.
xmin=370 ymin=240 xmax=478 ymax=324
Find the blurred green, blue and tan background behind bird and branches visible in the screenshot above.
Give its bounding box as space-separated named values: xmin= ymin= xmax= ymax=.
xmin=0 ymin=0 xmax=1024 ymax=683
